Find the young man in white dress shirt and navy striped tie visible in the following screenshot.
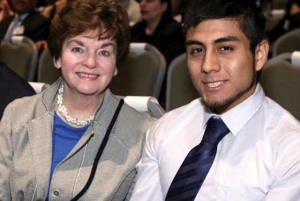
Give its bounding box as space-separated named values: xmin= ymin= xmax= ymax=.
xmin=131 ymin=0 xmax=300 ymax=201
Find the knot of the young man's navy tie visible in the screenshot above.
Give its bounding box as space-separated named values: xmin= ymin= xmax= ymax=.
xmin=202 ymin=116 xmax=229 ymax=145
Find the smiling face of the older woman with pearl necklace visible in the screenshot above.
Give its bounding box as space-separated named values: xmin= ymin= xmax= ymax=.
xmin=54 ymin=30 xmax=117 ymax=98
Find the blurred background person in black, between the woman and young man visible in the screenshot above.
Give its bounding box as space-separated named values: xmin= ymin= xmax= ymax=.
xmin=131 ymin=0 xmax=185 ymax=107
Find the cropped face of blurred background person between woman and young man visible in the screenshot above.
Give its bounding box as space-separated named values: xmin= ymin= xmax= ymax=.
xmin=140 ymin=0 xmax=168 ymax=22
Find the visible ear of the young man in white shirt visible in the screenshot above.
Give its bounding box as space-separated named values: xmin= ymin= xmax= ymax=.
xmin=255 ymin=39 xmax=269 ymax=71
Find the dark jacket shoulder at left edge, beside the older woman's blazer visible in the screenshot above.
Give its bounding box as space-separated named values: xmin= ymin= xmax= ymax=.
xmin=0 ymin=62 xmax=35 ymax=120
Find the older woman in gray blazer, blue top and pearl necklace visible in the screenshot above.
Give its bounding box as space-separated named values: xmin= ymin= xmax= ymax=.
xmin=0 ymin=0 xmax=153 ymax=201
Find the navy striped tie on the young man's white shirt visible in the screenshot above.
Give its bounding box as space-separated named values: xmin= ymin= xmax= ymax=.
xmin=166 ymin=116 xmax=229 ymax=201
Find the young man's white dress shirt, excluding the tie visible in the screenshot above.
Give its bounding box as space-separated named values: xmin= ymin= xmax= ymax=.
xmin=131 ymin=85 xmax=300 ymax=201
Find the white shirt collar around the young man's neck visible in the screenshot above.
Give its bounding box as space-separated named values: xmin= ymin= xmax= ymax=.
xmin=203 ymin=83 xmax=265 ymax=136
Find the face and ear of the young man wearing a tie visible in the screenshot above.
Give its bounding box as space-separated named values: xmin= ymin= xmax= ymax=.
xmin=186 ymin=18 xmax=269 ymax=114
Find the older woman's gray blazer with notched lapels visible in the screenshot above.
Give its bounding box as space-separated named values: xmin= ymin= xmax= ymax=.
xmin=0 ymin=79 xmax=154 ymax=201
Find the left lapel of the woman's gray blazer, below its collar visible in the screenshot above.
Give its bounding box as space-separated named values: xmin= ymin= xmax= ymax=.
xmin=28 ymin=113 xmax=53 ymax=197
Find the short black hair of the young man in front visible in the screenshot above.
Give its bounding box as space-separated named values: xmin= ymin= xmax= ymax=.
xmin=183 ymin=0 xmax=266 ymax=53
